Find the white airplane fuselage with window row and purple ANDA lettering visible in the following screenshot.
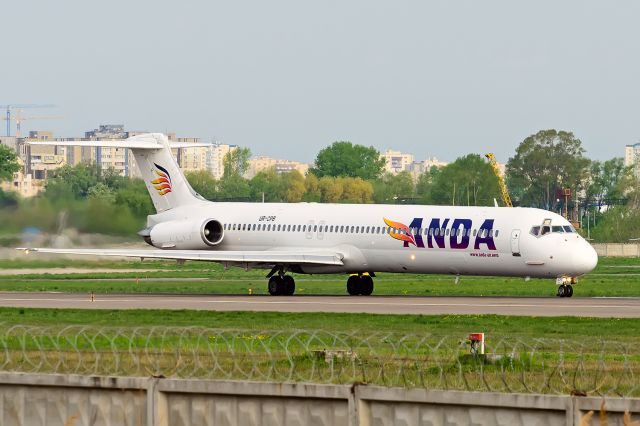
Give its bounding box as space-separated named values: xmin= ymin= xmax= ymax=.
xmin=148 ymin=201 xmax=597 ymax=278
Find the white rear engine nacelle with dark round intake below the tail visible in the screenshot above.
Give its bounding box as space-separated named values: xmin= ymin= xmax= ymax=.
xmin=141 ymin=219 xmax=224 ymax=250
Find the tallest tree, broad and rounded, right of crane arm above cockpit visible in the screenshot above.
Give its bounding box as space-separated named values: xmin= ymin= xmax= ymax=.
xmin=507 ymin=129 xmax=589 ymax=210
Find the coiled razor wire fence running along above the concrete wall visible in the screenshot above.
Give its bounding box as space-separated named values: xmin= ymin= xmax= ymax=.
xmin=0 ymin=324 xmax=640 ymax=397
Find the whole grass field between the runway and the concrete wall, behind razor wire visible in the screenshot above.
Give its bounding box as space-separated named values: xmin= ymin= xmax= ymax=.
xmin=0 ymin=308 xmax=640 ymax=396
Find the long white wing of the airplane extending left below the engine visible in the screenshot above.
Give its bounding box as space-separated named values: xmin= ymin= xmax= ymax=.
xmin=16 ymin=248 xmax=344 ymax=265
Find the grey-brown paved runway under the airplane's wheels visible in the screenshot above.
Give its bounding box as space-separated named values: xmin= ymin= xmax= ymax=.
xmin=0 ymin=292 xmax=640 ymax=318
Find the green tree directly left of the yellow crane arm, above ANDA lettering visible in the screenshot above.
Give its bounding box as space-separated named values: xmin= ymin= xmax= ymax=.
xmin=429 ymin=154 xmax=500 ymax=206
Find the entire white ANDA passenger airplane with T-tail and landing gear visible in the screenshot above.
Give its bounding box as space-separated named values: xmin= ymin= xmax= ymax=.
xmin=22 ymin=133 xmax=598 ymax=297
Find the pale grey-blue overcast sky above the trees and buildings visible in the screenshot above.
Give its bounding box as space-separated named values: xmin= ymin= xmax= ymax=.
xmin=0 ymin=0 xmax=640 ymax=162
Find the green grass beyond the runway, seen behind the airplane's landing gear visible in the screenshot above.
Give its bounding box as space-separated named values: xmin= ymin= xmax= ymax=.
xmin=0 ymin=257 xmax=640 ymax=297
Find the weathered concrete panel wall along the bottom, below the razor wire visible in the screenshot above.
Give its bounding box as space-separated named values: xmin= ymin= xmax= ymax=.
xmin=0 ymin=373 xmax=640 ymax=426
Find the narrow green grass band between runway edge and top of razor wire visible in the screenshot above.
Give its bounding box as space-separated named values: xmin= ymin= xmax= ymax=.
xmin=0 ymin=308 xmax=640 ymax=342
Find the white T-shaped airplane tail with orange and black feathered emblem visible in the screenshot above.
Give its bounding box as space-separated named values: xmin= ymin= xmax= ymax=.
xmin=26 ymin=133 xmax=207 ymax=212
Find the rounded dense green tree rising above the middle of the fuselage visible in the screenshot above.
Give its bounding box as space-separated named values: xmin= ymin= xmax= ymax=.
xmin=309 ymin=141 xmax=385 ymax=180
